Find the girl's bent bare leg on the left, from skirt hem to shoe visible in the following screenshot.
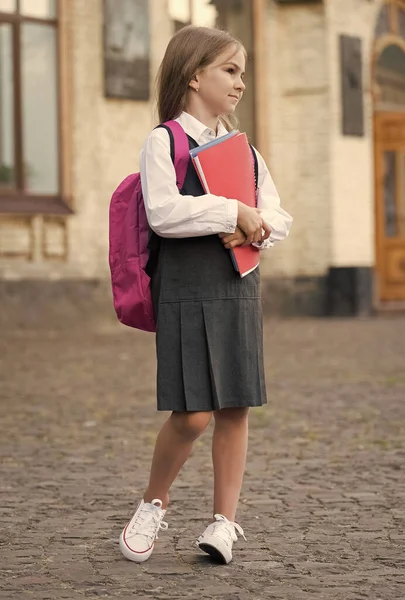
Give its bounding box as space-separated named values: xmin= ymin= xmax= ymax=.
xmin=143 ymin=412 xmax=212 ymax=508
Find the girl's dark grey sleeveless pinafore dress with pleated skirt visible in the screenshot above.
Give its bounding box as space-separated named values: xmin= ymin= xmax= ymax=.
xmin=148 ymin=137 xmax=267 ymax=411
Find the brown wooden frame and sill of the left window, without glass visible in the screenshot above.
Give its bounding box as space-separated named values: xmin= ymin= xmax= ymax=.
xmin=0 ymin=0 xmax=73 ymax=215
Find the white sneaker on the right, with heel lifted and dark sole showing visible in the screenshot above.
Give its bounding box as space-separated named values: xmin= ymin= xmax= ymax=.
xmin=196 ymin=515 xmax=246 ymax=564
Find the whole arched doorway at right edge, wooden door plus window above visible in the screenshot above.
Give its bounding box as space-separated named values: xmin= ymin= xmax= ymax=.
xmin=373 ymin=0 xmax=405 ymax=303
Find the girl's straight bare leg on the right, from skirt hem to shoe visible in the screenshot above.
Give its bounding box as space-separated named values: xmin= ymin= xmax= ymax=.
xmin=212 ymin=408 xmax=249 ymax=521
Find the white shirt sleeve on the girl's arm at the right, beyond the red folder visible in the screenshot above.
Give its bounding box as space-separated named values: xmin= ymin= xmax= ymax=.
xmin=251 ymin=150 xmax=293 ymax=250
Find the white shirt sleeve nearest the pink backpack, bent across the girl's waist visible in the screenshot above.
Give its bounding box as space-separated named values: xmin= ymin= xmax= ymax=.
xmin=140 ymin=128 xmax=238 ymax=238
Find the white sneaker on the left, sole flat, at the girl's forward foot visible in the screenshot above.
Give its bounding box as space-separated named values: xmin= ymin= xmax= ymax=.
xmin=120 ymin=500 xmax=168 ymax=562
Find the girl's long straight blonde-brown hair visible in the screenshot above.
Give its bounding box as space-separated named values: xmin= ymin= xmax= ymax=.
xmin=157 ymin=25 xmax=246 ymax=130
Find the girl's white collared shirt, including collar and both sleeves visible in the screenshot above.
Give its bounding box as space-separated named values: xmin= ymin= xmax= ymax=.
xmin=140 ymin=112 xmax=292 ymax=249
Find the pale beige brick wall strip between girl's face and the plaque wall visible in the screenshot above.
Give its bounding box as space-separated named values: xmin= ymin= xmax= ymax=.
xmin=263 ymin=2 xmax=331 ymax=276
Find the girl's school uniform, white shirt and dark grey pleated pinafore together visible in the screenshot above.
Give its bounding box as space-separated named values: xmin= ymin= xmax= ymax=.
xmin=140 ymin=112 xmax=292 ymax=411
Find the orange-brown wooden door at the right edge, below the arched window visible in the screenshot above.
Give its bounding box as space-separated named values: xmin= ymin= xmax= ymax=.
xmin=375 ymin=112 xmax=405 ymax=301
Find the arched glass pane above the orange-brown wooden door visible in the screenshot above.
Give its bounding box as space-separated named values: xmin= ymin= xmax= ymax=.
xmin=375 ymin=44 xmax=405 ymax=105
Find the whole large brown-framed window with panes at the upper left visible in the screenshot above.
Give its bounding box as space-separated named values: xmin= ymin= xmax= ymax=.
xmin=0 ymin=0 xmax=70 ymax=213
